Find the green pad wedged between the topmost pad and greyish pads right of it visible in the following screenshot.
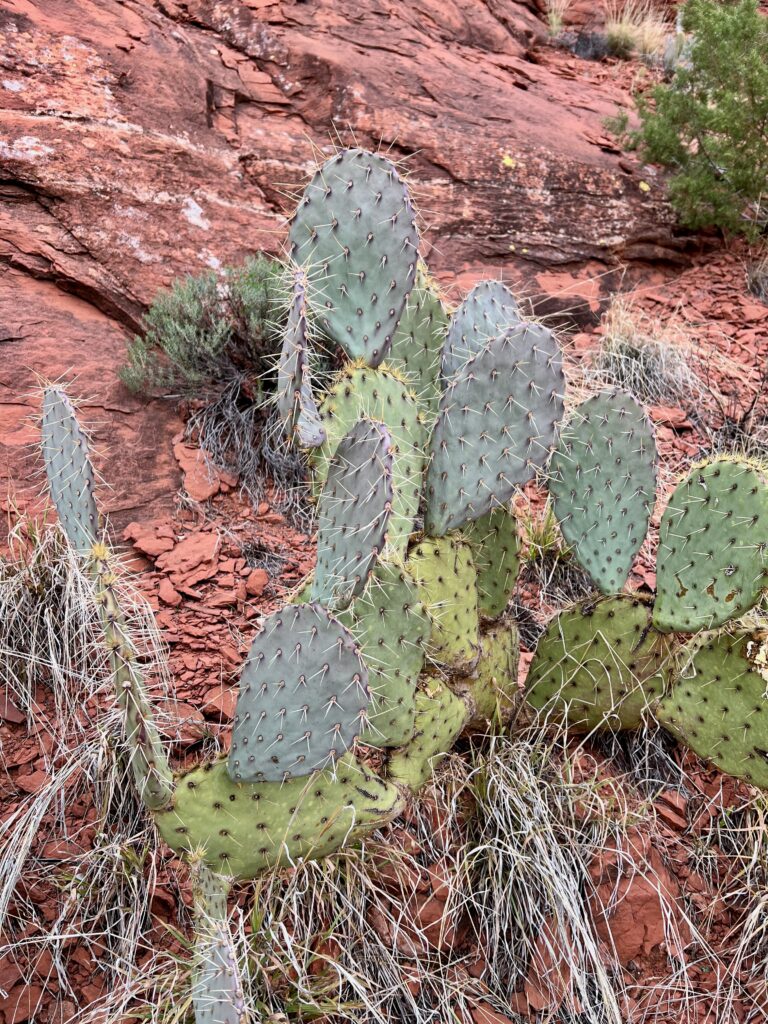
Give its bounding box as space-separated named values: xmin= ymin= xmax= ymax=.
xmin=387 ymin=282 xmax=447 ymax=413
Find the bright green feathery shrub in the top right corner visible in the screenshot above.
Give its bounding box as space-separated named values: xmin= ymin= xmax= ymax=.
xmin=638 ymin=0 xmax=768 ymax=234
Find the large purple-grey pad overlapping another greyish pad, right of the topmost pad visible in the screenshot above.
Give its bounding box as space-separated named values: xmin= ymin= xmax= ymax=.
xmin=425 ymin=324 xmax=563 ymax=537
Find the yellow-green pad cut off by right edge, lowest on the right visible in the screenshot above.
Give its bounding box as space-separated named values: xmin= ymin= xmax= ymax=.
xmin=656 ymin=633 xmax=768 ymax=790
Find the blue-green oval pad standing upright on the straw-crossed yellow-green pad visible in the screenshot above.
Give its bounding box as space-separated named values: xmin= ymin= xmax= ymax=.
xmin=549 ymin=391 xmax=656 ymax=594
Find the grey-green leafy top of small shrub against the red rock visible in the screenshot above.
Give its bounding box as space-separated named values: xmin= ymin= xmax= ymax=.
xmin=120 ymin=255 xmax=285 ymax=394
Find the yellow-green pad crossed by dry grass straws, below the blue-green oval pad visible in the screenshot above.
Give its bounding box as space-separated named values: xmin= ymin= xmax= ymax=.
xmin=525 ymin=594 xmax=670 ymax=732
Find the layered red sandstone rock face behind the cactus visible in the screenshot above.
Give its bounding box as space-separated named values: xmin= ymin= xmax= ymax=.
xmin=0 ymin=0 xmax=680 ymax=525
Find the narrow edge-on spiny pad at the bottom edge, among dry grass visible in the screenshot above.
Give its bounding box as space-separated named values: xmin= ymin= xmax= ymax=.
xmin=193 ymin=863 xmax=246 ymax=1024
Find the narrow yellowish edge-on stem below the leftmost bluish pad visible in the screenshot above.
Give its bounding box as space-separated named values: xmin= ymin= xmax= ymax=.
xmin=89 ymin=544 xmax=173 ymax=811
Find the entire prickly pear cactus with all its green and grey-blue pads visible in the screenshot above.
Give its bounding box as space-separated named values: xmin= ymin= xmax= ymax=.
xmin=44 ymin=150 xmax=768 ymax=1024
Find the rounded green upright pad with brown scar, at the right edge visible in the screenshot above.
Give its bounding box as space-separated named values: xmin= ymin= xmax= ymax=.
xmin=653 ymin=457 xmax=768 ymax=633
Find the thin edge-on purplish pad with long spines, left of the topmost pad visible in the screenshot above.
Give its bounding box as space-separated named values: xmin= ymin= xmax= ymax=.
xmin=278 ymin=270 xmax=326 ymax=447
